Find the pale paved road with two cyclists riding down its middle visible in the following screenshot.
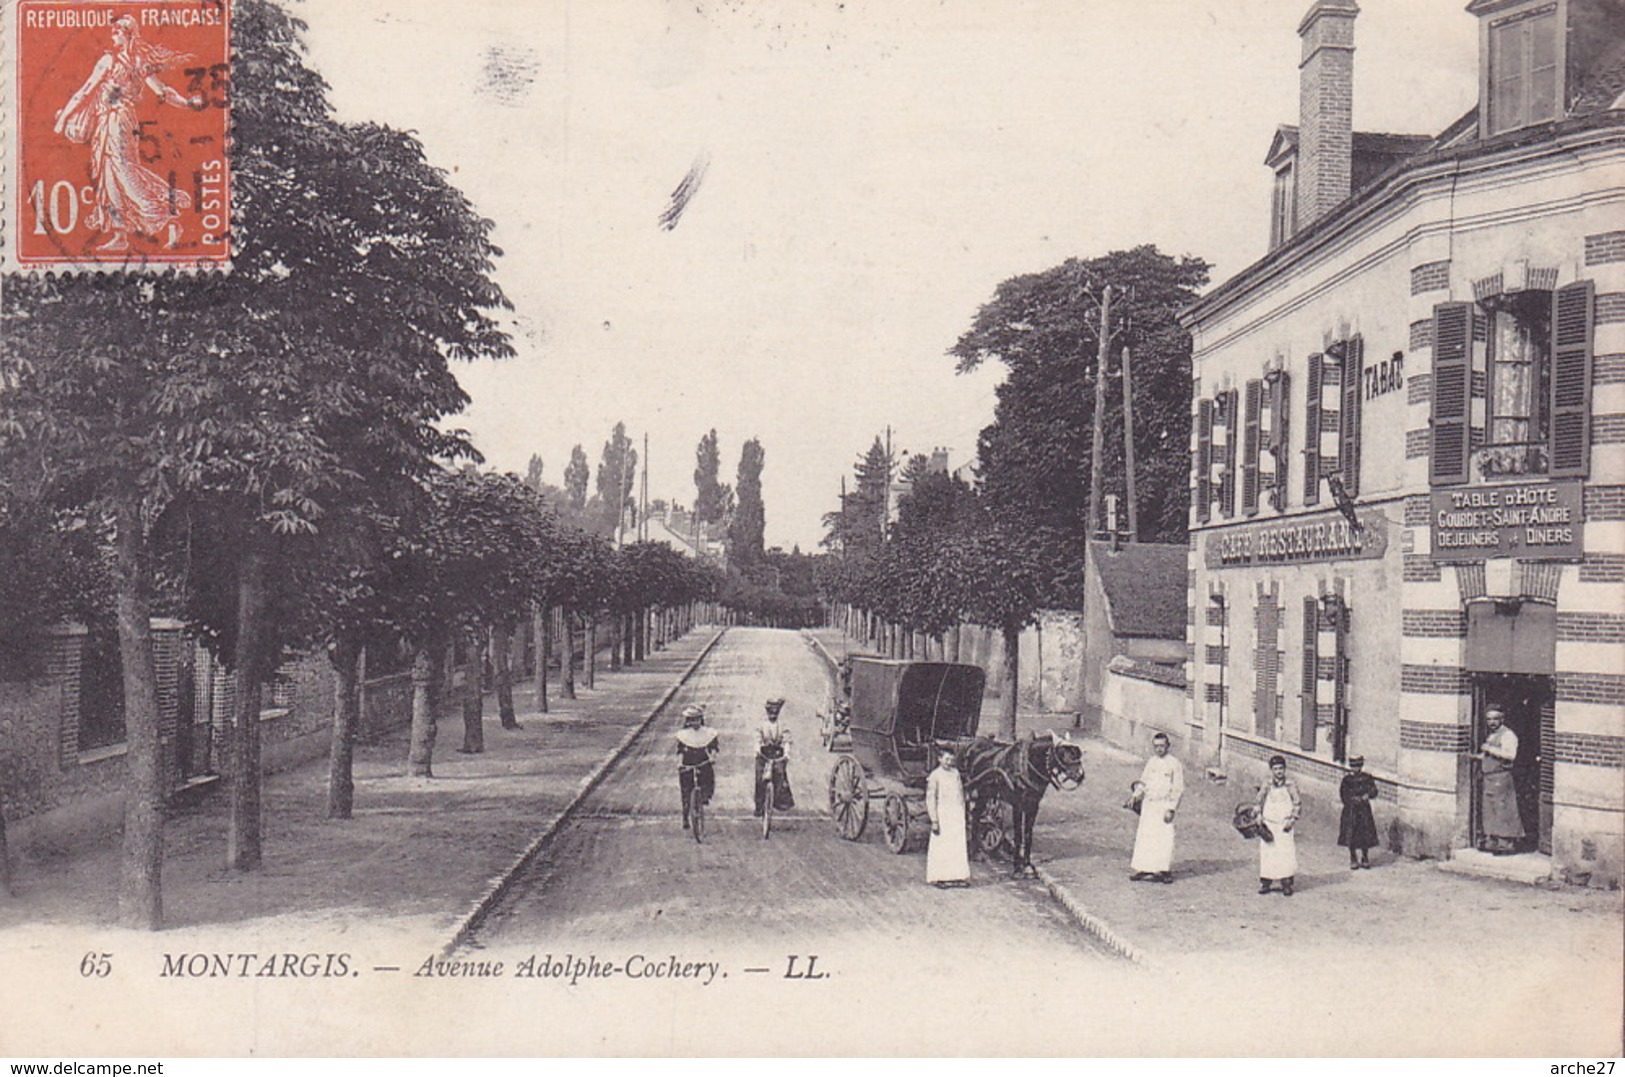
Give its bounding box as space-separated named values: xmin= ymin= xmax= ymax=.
xmin=470 ymin=629 xmax=1116 ymax=1035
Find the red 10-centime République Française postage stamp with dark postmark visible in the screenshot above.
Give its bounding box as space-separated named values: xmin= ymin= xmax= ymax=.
xmin=7 ymin=0 xmax=231 ymax=270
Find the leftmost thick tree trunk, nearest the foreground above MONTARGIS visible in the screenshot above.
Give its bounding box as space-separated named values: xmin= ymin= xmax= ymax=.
xmin=117 ymin=494 xmax=164 ymax=931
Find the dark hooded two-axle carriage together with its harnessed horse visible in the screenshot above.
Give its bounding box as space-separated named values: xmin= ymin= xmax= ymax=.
xmin=829 ymin=656 xmax=1084 ymax=871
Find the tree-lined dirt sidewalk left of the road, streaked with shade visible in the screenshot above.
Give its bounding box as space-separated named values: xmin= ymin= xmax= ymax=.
xmin=0 ymin=627 xmax=717 ymax=945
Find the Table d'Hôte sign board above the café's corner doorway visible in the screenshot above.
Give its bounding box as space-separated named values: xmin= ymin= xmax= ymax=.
xmin=1428 ymin=479 xmax=1584 ymax=560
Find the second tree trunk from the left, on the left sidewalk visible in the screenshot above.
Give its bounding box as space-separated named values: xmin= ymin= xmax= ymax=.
xmin=226 ymin=526 xmax=270 ymax=871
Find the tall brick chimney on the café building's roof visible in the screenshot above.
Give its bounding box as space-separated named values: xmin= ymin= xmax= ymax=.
xmin=1297 ymin=0 xmax=1360 ymax=229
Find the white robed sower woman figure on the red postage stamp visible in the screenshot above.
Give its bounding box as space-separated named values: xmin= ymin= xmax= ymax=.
xmin=55 ymin=15 xmax=203 ymax=252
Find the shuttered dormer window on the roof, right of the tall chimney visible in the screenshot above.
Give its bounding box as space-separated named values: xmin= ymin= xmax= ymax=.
xmin=1476 ymin=2 xmax=1563 ymax=135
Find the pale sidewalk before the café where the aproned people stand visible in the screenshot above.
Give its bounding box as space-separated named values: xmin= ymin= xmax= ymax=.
xmin=813 ymin=629 xmax=1625 ymax=984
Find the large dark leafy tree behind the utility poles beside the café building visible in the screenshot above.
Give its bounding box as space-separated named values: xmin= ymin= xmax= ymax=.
xmin=951 ymin=245 xmax=1209 ymax=571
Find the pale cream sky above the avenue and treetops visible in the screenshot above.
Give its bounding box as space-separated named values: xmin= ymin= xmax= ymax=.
xmin=291 ymin=0 xmax=1477 ymax=551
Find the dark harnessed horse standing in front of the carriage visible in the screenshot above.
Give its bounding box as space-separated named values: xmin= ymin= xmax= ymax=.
xmin=956 ymin=729 xmax=1084 ymax=879
